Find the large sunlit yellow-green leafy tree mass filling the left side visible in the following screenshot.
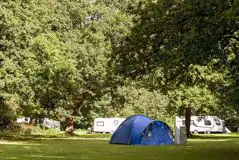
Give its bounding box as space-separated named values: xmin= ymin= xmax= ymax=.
xmin=0 ymin=0 xmax=136 ymax=132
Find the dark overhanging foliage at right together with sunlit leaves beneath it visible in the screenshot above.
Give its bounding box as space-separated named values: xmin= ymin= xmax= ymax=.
xmin=113 ymin=0 xmax=238 ymax=126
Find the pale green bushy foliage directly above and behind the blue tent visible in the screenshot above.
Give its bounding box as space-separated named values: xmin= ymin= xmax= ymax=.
xmin=118 ymin=86 xmax=169 ymax=119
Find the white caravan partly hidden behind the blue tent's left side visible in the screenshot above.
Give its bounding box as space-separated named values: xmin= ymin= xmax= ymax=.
xmin=93 ymin=118 xmax=125 ymax=133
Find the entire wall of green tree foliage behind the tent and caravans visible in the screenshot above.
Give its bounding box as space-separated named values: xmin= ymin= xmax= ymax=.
xmin=0 ymin=0 xmax=239 ymax=131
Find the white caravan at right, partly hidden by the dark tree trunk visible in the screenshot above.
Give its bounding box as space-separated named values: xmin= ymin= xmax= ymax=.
xmin=176 ymin=116 xmax=226 ymax=134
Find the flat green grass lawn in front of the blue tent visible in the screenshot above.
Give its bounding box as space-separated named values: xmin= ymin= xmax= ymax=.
xmin=0 ymin=134 xmax=239 ymax=160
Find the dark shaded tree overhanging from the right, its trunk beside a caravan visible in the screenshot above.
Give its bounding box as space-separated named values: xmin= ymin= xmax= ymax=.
xmin=114 ymin=0 xmax=238 ymax=135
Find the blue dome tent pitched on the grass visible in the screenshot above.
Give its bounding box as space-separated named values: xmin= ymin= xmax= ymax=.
xmin=110 ymin=115 xmax=173 ymax=145
